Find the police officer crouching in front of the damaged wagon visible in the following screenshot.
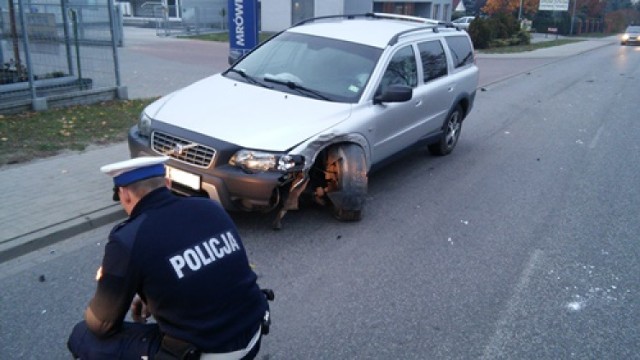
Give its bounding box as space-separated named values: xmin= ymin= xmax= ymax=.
xmin=67 ymin=157 xmax=268 ymax=360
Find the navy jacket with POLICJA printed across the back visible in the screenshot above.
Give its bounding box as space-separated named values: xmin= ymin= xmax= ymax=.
xmin=88 ymin=188 xmax=268 ymax=352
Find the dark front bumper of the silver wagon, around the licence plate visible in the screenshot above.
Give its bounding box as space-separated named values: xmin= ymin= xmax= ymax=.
xmin=128 ymin=126 xmax=290 ymax=211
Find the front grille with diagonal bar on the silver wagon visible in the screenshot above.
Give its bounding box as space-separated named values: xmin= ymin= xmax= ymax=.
xmin=151 ymin=131 xmax=216 ymax=168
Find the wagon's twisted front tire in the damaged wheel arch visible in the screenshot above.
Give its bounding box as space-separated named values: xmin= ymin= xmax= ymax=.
xmin=326 ymin=144 xmax=368 ymax=221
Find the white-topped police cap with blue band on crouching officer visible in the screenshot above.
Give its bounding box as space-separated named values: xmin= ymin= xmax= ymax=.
xmin=100 ymin=156 xmax=169 ymax=186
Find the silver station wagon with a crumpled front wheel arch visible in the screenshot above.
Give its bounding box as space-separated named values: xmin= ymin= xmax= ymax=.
xmin=128 ymin=13 xmax=478 ymax=228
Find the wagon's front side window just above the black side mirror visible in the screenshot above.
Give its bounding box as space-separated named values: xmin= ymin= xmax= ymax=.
xmin=376 ymin=45 xmax=418 ymax=94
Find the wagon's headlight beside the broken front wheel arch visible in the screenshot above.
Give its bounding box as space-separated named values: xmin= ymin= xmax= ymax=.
xmin=229 ymin=149 xmax=304 ymax=172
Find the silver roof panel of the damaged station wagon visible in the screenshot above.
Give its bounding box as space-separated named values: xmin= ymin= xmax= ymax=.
xmin=286 ymin=17 xmax=448 ymax=49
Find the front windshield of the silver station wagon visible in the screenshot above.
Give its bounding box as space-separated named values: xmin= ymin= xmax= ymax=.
xmin=225 ymin=32 xmax=382 ymax=103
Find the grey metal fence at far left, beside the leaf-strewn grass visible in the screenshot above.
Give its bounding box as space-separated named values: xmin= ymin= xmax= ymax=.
xmin=0 ymin=0 xmax=126 ymax=113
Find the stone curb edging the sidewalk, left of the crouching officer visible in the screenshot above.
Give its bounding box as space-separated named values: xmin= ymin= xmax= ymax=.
xmin=0 ymin=204 xmax=127 ymax=264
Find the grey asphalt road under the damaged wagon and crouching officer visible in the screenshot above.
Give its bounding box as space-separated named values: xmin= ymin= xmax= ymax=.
xmin=0 ymin=46 xmax=640 ymax=360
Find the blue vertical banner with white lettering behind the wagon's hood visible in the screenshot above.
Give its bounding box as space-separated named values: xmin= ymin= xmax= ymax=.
xmin=228 ymin=0 xmax=258 ymax=63
